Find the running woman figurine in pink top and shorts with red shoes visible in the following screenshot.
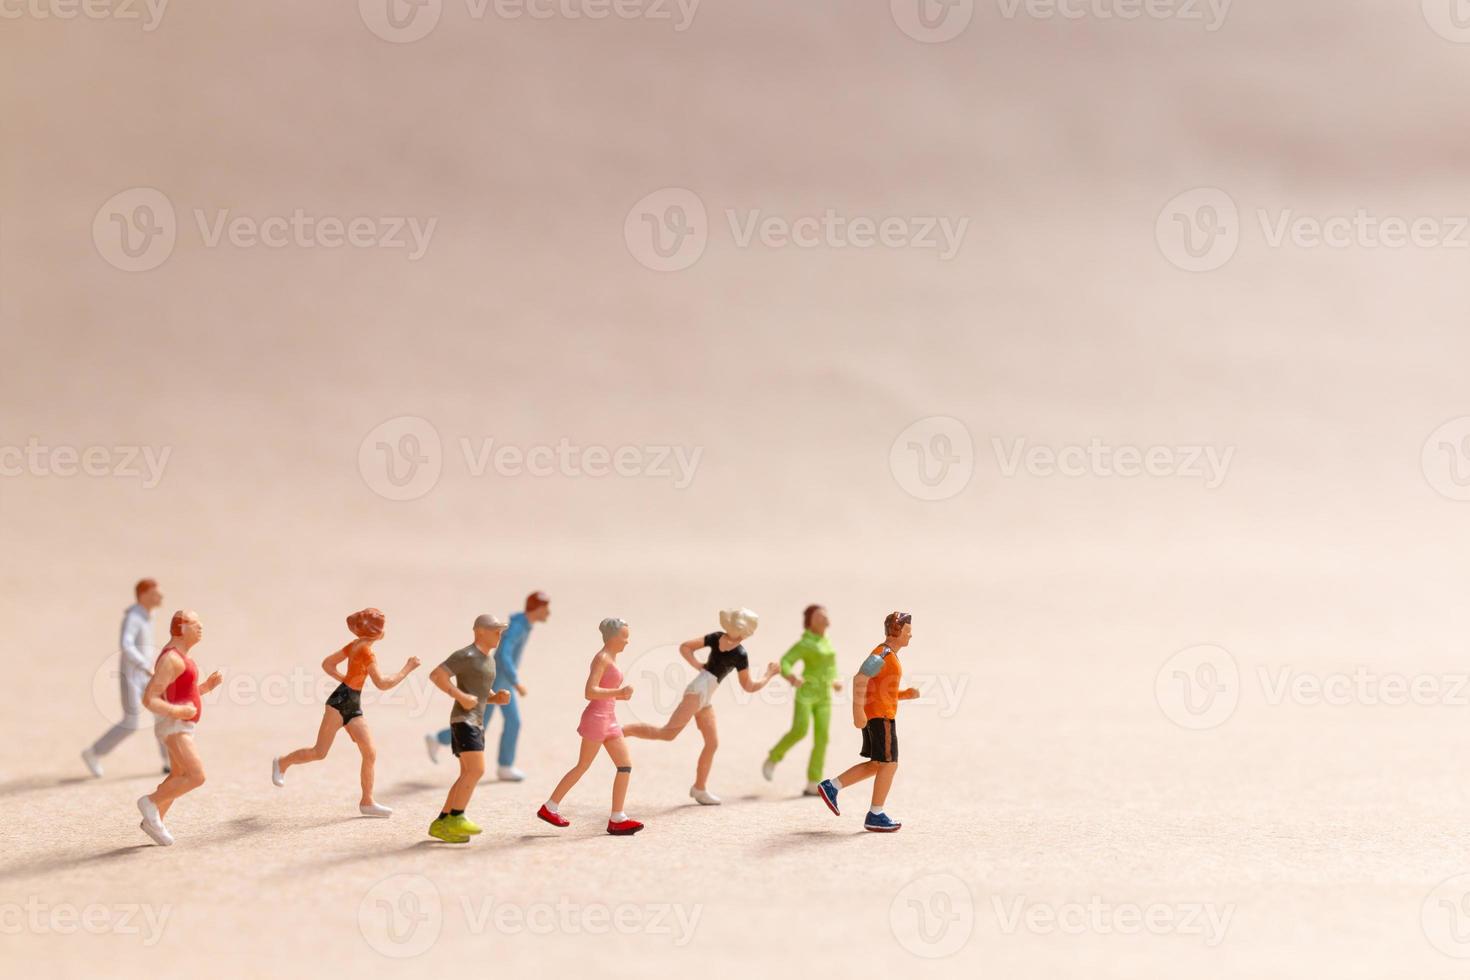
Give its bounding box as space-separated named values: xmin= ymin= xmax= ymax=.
xmin=537 ymin=619 xmax=642 ymax=837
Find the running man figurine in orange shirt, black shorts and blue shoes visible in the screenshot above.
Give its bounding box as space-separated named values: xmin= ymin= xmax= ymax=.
xmin=817 ymin=613 xmax=919 ymax=833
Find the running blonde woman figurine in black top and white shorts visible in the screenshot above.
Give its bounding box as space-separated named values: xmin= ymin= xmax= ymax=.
xmin=623 ymin=608 xmax=778 ymax=807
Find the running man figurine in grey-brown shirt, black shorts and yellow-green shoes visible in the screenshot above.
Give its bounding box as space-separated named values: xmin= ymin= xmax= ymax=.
xmin=429 ymin=614 xmax=510 ymax=843
